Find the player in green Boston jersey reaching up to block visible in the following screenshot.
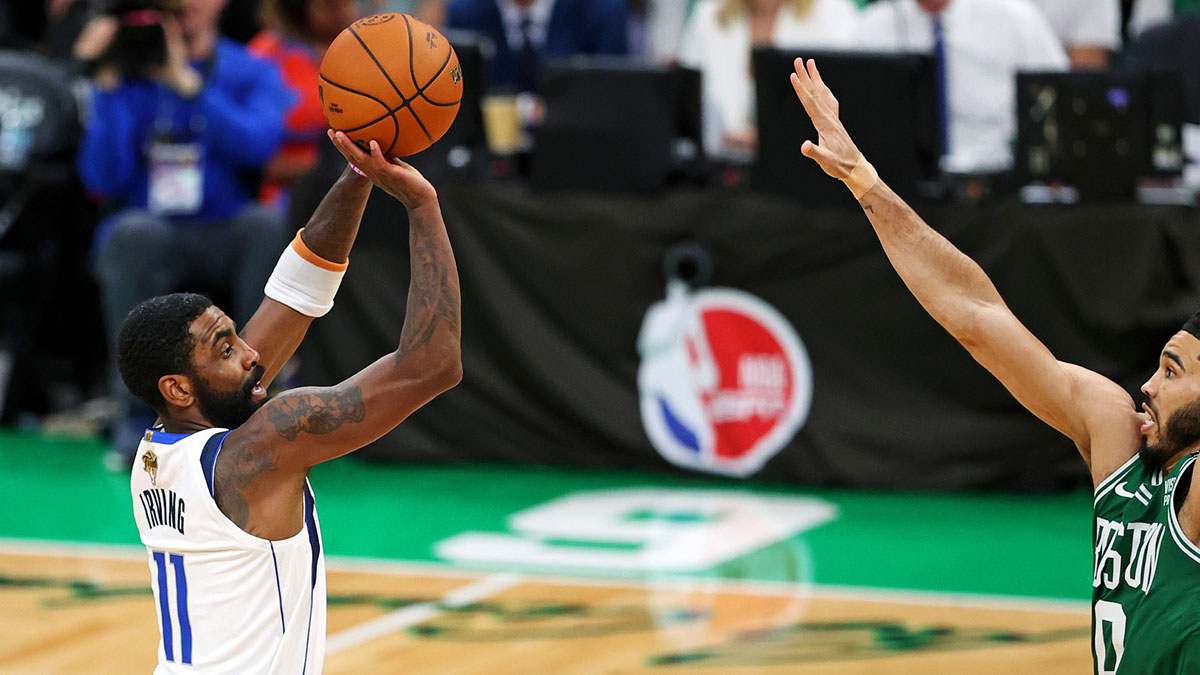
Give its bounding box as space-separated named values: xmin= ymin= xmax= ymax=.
xmin=791 ymin=59 xmax=1200 ymax=675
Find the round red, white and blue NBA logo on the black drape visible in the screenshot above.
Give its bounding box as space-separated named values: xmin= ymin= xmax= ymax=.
xmin=637 ymin=279 xmax=812 ymax=476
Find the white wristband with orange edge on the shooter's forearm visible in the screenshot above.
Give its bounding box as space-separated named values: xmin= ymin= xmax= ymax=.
xmin=263 ymin=229 xmax=349 ymax=317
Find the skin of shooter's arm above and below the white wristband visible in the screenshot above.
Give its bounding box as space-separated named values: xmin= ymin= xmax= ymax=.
xmin=231 ymin=142 xmax=371 ymax=387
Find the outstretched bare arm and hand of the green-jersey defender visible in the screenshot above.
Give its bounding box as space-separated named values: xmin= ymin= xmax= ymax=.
xmin=792 ymin=59 xmax=1140 ymax=484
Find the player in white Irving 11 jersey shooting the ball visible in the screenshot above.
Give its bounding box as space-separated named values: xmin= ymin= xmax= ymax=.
xmin=118 ymin=132 xmax=462 ymax=675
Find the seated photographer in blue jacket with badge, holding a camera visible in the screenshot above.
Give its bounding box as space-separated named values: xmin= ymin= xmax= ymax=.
xmin=76 ymin=0 xmax=293 ymax=465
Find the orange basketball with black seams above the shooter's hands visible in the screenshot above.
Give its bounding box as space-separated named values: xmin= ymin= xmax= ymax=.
xmin=318 ymin=13 xmax=462 ymax=157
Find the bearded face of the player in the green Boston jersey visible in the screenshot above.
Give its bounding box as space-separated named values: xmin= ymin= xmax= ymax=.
xmin=1141 ymin=330 xmax=1200 ymax=461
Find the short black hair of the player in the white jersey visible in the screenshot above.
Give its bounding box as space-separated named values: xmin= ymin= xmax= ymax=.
xmin=116 ymin=293 xmax=212 ymax=414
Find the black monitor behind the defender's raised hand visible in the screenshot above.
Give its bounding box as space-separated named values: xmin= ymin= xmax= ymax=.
xmin=751 ymin=48 xmax=942 ymax=204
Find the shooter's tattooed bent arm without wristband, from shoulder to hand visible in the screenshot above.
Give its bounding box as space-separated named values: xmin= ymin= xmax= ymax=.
xmin=214 ymin=135 xmax=462 ymax=538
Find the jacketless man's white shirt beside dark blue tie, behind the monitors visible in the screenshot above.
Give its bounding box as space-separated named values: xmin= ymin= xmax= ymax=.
xmin=854 ymin=0 xmax=1069 ymax=173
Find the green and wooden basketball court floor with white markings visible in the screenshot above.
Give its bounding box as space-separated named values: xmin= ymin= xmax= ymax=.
xmin=0 ymin=434 xmax=1092 ymax=675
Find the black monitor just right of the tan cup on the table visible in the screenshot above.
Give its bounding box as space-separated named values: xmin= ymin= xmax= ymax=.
xmin=530 ymin=56 xmax=703 ymax=192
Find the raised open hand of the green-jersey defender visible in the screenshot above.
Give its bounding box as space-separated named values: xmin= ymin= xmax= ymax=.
xmin=791 ymin=59 xmax=862 ymax=180
